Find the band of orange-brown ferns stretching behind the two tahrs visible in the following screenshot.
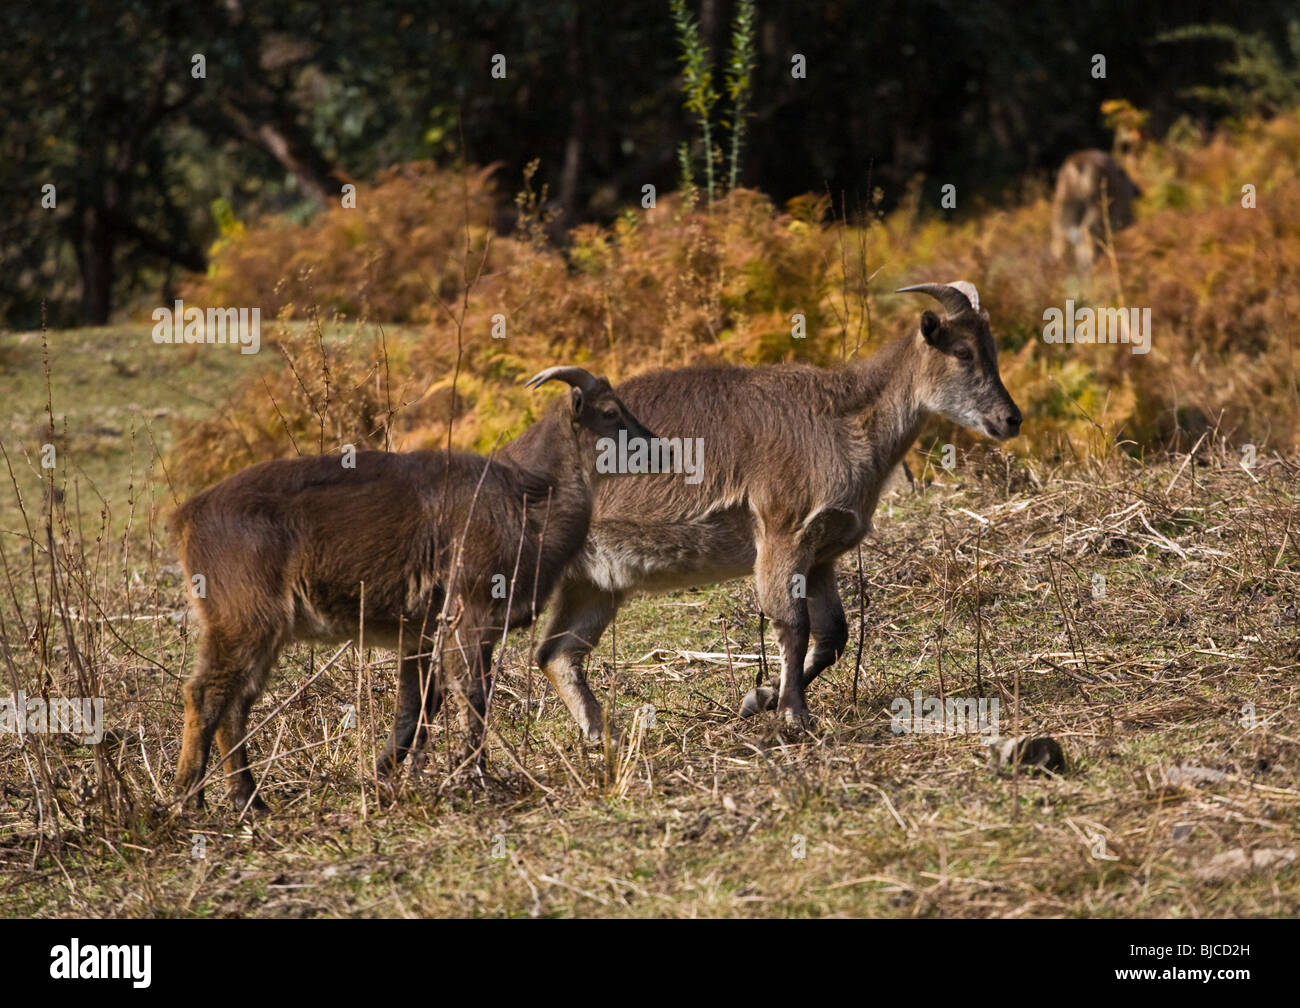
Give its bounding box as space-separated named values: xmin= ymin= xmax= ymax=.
xmin=177 ymin=116 xmax=1300 ymax=494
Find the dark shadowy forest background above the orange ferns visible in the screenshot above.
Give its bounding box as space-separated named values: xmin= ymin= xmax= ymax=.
xmin=0 ymin=0 xmax=1296 ymax=328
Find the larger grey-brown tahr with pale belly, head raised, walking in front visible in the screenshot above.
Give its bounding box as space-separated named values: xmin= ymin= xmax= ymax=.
xmin=537 ymin=282 xmax=1021 ymax=739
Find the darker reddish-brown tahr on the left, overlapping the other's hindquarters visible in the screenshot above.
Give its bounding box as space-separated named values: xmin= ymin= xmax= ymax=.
xmin=174 ymin=368 xmax=650 ymax=809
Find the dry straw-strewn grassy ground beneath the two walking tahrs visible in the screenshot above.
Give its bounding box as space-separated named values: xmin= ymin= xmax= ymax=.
xmin=0 ymin=329 xmax=1300 ymax=917
